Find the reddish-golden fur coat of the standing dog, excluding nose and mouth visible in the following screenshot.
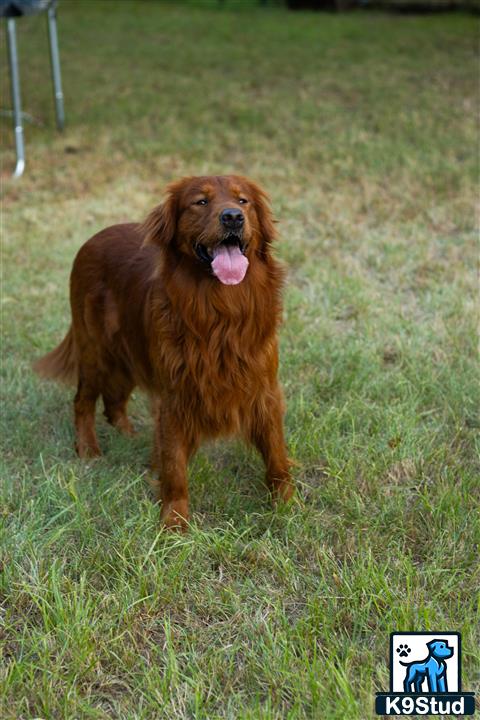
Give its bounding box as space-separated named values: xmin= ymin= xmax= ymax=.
xmin=35 ymin=176 xmax=293 ymax=527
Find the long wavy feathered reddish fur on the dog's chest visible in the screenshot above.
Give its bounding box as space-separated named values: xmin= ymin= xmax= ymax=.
xmin=150 ymin=264 xmax=281 ymax=433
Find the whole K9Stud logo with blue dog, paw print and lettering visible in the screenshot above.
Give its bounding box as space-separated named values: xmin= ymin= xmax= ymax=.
xmin=375 ymin=632 xmax=475 ymax=716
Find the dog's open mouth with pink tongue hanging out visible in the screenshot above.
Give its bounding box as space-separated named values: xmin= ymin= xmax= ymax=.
xmin=195 ymin=233 xmax=248 ymax=285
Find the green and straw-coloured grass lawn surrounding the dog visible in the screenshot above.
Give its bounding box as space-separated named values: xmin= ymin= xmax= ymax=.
xmin=0 ymin=0 xmax=480 ymax=720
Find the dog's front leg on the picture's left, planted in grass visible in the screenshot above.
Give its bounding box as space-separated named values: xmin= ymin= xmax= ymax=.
xmin=154 ymin=402 xmax=196 ymax=531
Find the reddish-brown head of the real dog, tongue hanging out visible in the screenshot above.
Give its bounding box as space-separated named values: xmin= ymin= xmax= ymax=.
xmin=143 ymin=175 xmax=275 ymax=285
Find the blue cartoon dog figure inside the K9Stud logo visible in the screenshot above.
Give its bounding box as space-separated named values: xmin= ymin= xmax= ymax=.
xmin=397 ymin=639 xmax=454 ymax=693
